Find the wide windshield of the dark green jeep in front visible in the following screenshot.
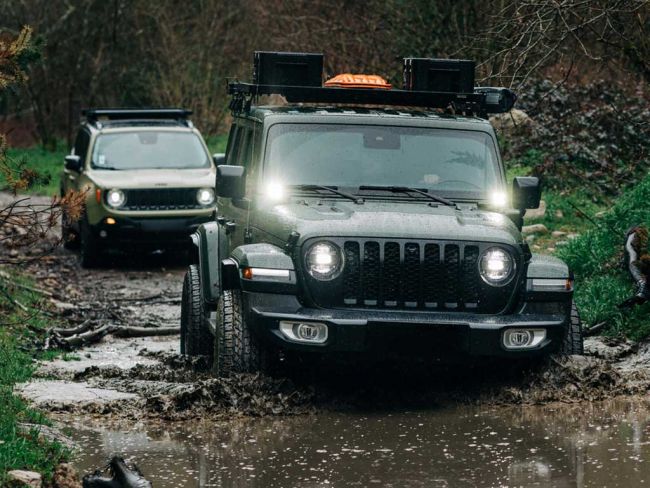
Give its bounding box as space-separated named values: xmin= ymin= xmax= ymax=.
xmin=264 ymin=124 xmax=502 ymax=198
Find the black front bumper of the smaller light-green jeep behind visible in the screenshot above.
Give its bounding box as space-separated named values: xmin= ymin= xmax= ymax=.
xmin=91 ymin=216 xmax=212 ymax=246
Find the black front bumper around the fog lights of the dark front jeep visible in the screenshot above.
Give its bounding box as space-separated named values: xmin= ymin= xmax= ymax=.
xmin=244 ymin=292 xmax=567 ymax=357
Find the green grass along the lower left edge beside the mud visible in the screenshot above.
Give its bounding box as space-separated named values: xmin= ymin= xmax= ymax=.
xmin=0 ymin=273 xmax=68 ymax=486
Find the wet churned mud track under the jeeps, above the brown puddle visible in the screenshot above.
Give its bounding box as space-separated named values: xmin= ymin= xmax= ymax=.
xmin=3 ymin=193 xmax=650 ymax=420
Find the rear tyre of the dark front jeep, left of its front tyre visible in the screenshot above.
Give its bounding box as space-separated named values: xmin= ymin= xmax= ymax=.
xmin=181 ymin=264 xmax=214 ymax=356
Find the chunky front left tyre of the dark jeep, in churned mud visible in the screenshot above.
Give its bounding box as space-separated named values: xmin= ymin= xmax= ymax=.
xmin=212 ymin=290 xmax=267 ymax=377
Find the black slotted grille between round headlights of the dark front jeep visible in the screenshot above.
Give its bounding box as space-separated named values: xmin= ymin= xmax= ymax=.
xmin=304 ymin=239 xmax=521 ymax=314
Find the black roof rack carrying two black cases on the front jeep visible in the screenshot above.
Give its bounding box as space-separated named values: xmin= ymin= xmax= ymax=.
xmin=228 ymin=51 xmax=517 ymax=117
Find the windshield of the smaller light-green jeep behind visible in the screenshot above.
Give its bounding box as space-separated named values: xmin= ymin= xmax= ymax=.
xmin=92 ymin=130 xmax=210 ymax=170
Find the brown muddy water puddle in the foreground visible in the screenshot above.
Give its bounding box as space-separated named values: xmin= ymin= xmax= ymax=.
xmin=61 ymin=398 xmax=650 ymax=487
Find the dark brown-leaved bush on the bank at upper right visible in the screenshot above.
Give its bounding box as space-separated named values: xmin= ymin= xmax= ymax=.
xmin=504 ymin=80 xmax=650 ymax=199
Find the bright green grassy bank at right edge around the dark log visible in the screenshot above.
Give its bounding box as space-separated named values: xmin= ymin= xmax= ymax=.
xmin=558 ymin=176 xmax=650 ymax=340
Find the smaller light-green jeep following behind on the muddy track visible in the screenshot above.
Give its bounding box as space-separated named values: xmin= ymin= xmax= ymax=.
xmin=61 ymin=109 xmax=219 ymax=267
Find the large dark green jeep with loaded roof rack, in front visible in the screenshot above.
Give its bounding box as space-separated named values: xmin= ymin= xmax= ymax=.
xmin=181 ymin=53 xmax=582 ymax=375
